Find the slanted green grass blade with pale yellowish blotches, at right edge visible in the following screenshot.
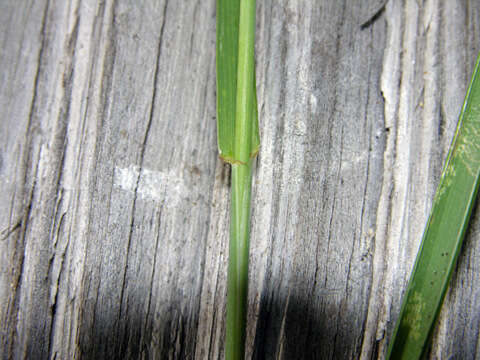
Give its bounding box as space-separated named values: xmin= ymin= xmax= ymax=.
xmin=387 ymin=52 xmax=480 ymax=360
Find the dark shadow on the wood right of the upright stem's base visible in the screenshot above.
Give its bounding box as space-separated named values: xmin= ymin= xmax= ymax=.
xmin=253 ymin=289 xmax=360 ymax=360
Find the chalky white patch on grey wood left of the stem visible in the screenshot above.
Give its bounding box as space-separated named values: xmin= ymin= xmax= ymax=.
xmin=113 ymin=165 xmax=188 ymax=201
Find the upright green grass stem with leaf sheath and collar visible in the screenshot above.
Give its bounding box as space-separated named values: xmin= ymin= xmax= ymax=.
xmin=216 ymin=0 xmax=260 ymax=360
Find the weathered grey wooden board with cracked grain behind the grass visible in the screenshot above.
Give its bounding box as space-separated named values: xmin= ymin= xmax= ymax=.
xmin=0 ymin=0 xmax=480 ymax=359
